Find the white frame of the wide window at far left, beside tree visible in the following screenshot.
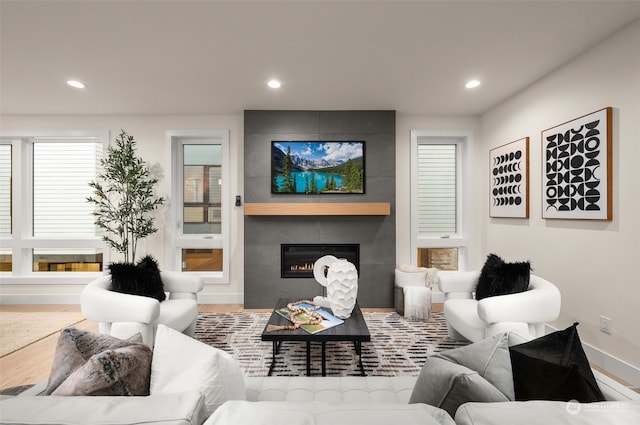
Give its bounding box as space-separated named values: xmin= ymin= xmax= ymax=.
xmin=0 ymin=131 xmax=109 ymax=284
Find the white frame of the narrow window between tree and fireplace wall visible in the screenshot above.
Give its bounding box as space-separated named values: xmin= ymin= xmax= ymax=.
xmin=165 ymin=130 xmax=231 ymax=285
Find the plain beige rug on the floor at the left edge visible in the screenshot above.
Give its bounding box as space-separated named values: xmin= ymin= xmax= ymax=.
xmin=0 ymin=311 xmax=84 ymax=357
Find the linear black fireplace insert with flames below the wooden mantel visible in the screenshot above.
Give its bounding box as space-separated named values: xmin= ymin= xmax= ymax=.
xmin=280 ymin=244 xmax=360 ymax=279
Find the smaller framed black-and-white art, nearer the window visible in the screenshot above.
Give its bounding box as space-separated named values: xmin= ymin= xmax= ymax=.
xmin=489 ymin=137 xmax=529 ymax=218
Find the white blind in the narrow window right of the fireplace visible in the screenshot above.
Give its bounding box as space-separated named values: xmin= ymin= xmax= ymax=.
xmin=417 ymin=144 xmax=457 ymax=235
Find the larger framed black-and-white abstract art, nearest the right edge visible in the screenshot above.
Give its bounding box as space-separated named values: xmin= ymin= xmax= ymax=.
xmin=541 ymin=107 xmax=612 ymax=220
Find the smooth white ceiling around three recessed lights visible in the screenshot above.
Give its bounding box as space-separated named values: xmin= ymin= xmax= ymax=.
xmin=0 ymin=0 xmax=640 ymax=115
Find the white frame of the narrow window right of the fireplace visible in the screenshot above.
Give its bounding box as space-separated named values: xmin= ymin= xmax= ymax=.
xmin=411 ymin=130 xmax=473 ymax=270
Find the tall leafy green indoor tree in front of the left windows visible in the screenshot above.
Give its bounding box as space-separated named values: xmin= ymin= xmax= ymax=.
xmin=87 ymin=130 xmax=164 ymax=263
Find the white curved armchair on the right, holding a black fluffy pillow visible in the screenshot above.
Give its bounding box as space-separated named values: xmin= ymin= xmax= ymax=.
xmin=439 ymin=271 xmax=561 ymax=342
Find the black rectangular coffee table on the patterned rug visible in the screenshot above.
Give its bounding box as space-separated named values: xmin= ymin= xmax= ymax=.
xmin=262 ymin=298 xmax=371 ymax=376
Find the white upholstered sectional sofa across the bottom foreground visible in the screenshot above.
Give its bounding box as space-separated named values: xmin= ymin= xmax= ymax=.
xmin=0 ymin=371 xmax=640 ymax=425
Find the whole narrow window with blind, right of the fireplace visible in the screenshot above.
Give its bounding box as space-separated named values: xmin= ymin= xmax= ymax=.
xmin=411 ymin=131 xmax=471 ymax=270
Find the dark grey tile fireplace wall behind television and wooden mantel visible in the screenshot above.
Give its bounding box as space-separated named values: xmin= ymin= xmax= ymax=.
xmin=243 ymin=110 xmax=396 ymax=309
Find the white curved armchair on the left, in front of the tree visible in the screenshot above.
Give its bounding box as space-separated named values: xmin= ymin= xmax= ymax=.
xmin=80 ymin=271 xmax=202 ymax=347
